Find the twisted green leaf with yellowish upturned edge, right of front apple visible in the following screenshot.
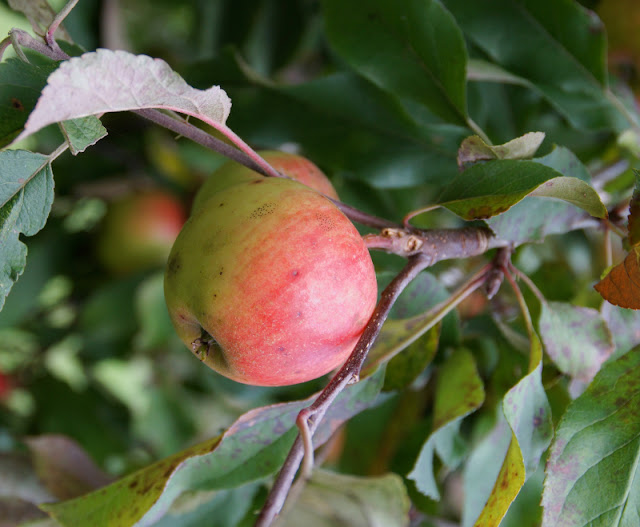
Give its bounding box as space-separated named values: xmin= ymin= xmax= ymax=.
xmin=438 ymin=159 xmax=606 ymax=220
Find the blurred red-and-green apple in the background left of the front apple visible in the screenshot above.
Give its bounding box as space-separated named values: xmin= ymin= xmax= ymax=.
xmin=97 ymin=190 xmax=187 ymax=275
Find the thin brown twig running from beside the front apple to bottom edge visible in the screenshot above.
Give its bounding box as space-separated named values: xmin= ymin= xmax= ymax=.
xmin=255 ymin=254 xmax=430 ymax=527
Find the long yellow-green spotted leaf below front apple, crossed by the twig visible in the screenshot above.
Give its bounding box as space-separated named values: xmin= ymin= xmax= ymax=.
xmin=42 ymin=371 xmax=383 ymax=527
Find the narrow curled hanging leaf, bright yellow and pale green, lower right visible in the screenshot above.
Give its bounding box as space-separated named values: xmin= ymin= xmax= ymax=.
xmin=475 ymin=333 xmax=553 ymax=527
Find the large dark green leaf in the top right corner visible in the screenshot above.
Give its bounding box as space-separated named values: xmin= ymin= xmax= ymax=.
xmin=443 ymin=0 xmax=629 ymax=131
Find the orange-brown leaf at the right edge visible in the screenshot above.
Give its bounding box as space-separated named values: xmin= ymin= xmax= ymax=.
xmin=594 ymin=247 xmax=640 ymax=309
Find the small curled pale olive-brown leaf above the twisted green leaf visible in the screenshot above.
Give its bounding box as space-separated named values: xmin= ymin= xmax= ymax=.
xmin=458 ymin=132 xmax=545 ymax=169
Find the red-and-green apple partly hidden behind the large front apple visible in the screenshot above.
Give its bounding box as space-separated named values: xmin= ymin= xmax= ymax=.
xmin=191 ymin=150 xmax=339 ymax=214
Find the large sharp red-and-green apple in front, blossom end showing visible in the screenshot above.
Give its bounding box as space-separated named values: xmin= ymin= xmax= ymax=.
xmin=165 ymin=177 xmax=377 ymax=386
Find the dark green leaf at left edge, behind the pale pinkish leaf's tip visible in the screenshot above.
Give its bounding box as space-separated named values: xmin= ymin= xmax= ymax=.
xmin=0 ymin=58 xmax=58 ymax=147
